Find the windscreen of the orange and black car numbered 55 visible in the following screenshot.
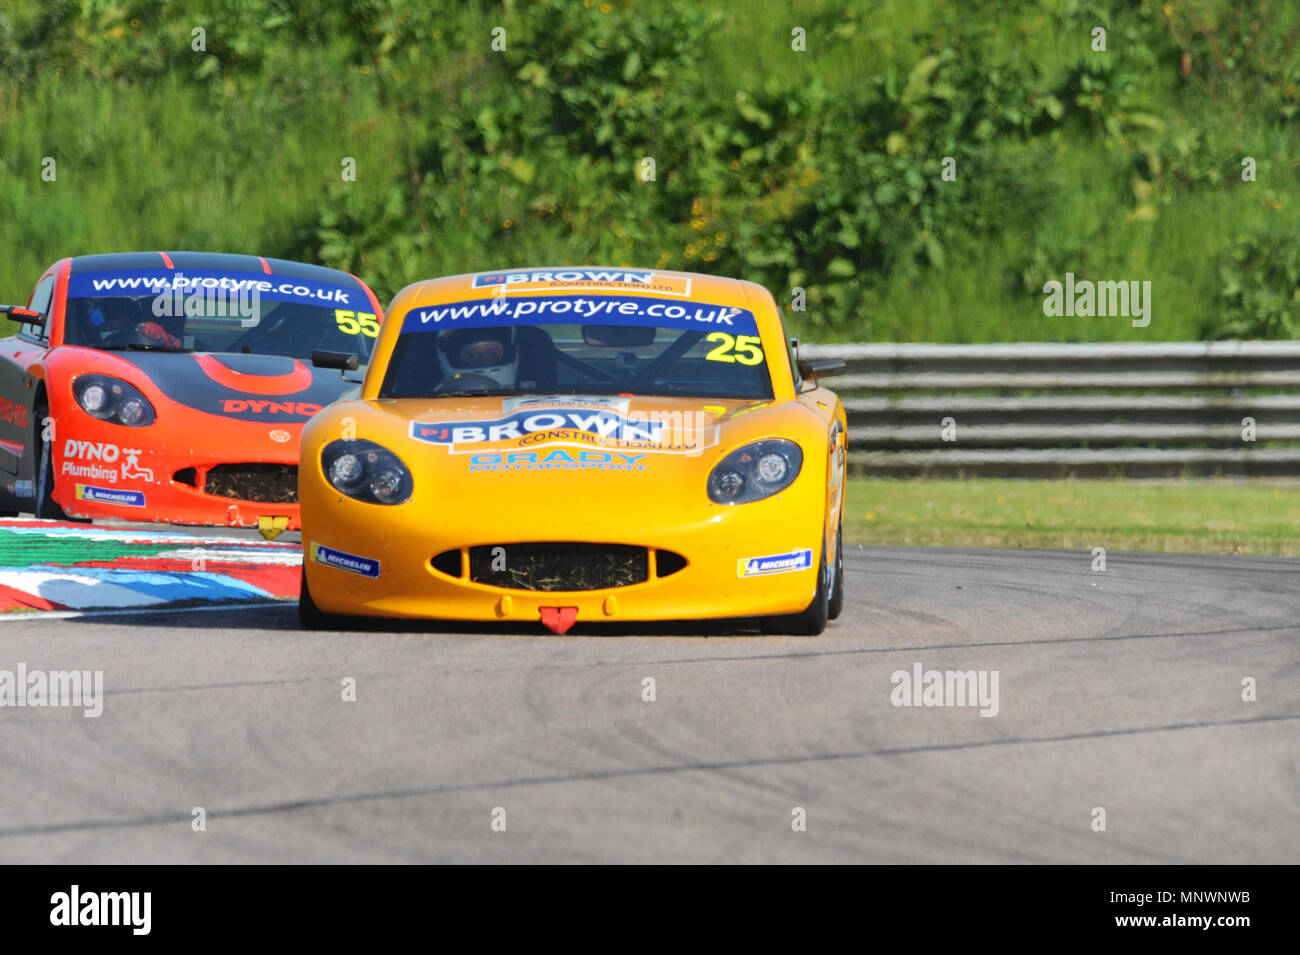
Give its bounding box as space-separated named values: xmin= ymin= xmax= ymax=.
xmin=64 ymin=269 xmax=380 ymax=364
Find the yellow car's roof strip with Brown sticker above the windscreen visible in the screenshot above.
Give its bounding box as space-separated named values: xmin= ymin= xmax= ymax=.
xmin=394 ymin=265 xmax=770 ymax=308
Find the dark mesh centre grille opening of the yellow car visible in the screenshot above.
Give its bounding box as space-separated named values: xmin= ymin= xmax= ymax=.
xmin=469 ymin=542 xmax=650 ymax=590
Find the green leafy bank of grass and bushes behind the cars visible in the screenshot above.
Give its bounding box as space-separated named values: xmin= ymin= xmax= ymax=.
xmin=0 ymin=0 xmax=1300 ymax=340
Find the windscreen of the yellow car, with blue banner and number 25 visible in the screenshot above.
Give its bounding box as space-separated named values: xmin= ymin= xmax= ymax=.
xmin=380 ymin=295 xmax=772 ymax=399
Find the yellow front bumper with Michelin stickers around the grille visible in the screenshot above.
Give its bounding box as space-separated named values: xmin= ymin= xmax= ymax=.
xmin=302 ymin=478 xmax=826 ymax=622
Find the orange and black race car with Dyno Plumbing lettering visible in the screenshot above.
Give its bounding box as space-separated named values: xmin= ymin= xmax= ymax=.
xmin=0 ymin=252 xmax=382 ymax=537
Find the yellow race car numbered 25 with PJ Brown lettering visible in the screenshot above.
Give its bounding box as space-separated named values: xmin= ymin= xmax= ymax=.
xmin=299 ymin=266 xmax=846 ymax=634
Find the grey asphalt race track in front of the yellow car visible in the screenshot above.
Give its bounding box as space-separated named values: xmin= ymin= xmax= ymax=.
xmin=0 ymin=548 xmax=1300 ymax=863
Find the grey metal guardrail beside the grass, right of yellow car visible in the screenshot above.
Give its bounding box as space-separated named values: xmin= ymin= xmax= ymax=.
xmin=800 ymin=342 xmax=1300 ymax=477
